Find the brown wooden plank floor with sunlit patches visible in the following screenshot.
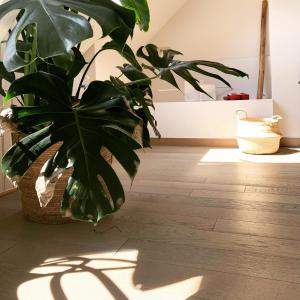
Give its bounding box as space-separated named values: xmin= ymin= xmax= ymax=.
xmin=0 ymin=147 xmax=300 ymax=300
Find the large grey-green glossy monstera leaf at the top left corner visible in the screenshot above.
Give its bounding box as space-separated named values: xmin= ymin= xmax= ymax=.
xmin=0 ymin=0 xmax=137 ymax=71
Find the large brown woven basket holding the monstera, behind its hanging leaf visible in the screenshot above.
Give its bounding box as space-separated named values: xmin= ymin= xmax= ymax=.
xmin=12 ymin=134 xmax=112 ymax=224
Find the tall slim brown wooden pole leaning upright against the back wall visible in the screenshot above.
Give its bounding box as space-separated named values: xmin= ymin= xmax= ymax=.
xmin=257 ymin=0 xmax=268 ymax=99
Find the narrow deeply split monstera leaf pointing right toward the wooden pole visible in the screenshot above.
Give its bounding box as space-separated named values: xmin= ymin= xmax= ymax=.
xmin=137 ymin=44 xmax=248 ymax=96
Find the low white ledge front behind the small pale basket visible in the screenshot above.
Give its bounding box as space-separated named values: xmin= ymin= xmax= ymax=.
xmin=151 ymin=99 xmax=273 ymax=139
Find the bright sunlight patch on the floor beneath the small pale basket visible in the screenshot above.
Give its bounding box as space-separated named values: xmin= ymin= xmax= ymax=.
xmin=198 ymin=148 xmax=300 ymax=165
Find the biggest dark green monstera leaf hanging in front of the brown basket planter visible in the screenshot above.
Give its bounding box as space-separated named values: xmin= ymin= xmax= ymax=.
xmin=2 ymin=72 xmax=141 ymax=223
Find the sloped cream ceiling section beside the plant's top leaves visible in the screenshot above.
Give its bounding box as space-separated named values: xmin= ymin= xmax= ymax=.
xmin=82 ymin=0 xmax=188 ymax=52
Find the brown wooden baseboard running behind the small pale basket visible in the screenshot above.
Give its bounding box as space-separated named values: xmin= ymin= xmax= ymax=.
xmin=151 ymin=138 xmax=300 ymax=148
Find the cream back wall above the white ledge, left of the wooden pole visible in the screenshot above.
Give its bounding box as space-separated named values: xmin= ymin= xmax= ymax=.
xmin=153 ymin=0 xmax=271 ymax=101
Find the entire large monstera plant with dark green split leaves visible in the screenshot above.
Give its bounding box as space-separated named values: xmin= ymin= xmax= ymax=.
xmin=0 ymin=0 xmax=246 ymax=223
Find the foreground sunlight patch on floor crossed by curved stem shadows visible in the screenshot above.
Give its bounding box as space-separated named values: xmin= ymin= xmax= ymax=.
xmin=17 ymin=249 xmax=202 ymax=300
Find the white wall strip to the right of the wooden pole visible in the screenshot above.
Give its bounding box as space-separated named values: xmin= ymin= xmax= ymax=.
xmin=269 ymin=0 xmax=300 ymax=138
